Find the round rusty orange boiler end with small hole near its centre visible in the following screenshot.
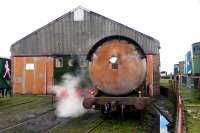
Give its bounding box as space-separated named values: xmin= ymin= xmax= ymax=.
xmin=89 ymin=39 xmax=146 ymax=96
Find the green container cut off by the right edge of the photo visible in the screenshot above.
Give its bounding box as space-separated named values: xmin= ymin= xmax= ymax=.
xmin=192 ymin=55 xmax=200 ymax=76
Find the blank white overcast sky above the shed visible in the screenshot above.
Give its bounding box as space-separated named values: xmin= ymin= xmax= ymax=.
xmin=0 ymin=0 xmax=200 ymax=72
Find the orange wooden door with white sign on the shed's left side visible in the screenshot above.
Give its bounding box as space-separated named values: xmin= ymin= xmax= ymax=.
xmin=13 ymin=57 xmax=53 ymax=94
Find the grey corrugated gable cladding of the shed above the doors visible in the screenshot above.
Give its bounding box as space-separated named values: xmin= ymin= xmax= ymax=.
xmin=11 ymin=10 xmax=159 ymax=56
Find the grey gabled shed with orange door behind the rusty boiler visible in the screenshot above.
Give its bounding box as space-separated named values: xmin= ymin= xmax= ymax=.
xmin=11 ymin=7 xmax=160 ymax=94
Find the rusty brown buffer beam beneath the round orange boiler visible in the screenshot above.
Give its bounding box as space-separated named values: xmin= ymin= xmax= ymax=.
xmin=83 ymin=97 xmax=153 ymax=110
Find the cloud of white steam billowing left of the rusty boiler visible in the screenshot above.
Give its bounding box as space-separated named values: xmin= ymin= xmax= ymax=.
xmin=53 ymin=74 xmax=86 ymax=117
